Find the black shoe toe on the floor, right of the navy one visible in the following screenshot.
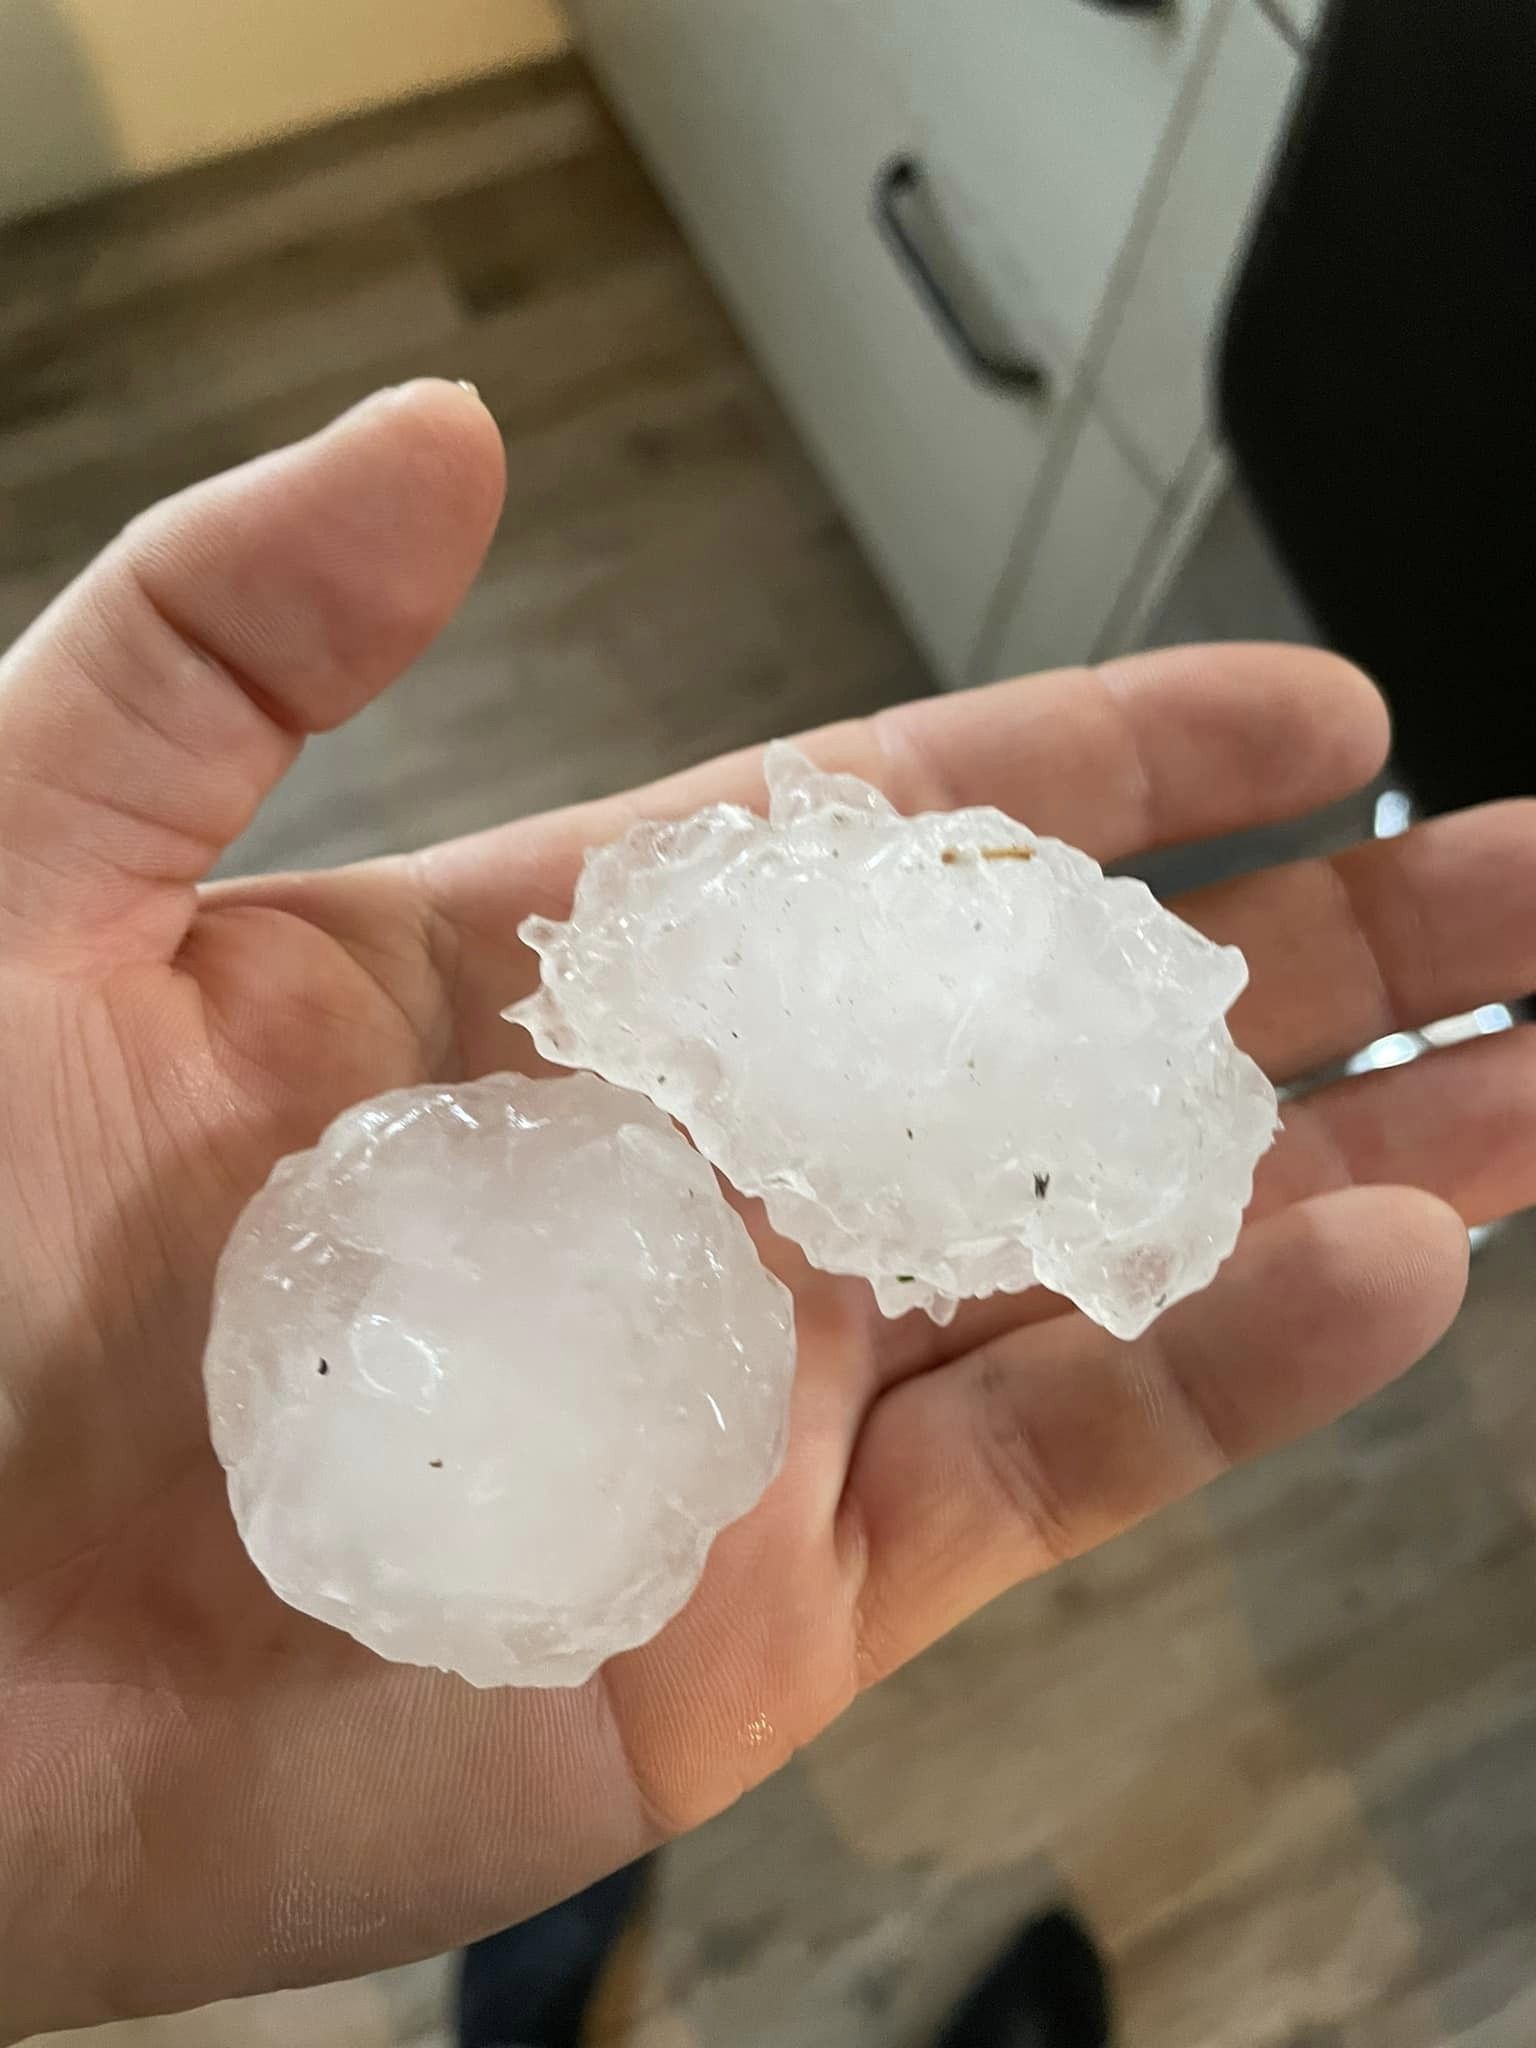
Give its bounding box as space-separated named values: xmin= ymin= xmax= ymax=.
xmin=936 ymin=1911 xmax=1112 ymax=2048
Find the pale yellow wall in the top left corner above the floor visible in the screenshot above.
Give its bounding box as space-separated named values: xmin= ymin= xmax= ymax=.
xmin=0 ymin=0 xmax=565 ymax=217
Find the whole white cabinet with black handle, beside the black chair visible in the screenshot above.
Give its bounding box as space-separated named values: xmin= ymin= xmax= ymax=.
xmin=569 ymin=0 xmax=1296 ymax=684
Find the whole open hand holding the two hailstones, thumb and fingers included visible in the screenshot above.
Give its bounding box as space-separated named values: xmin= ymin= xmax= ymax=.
xmin=0 ymin=385 xmax=1536 ymax=2038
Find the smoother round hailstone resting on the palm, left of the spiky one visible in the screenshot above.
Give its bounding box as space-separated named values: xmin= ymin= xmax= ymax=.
xmin=207 ymin=1075 xmax=795 ymax=1686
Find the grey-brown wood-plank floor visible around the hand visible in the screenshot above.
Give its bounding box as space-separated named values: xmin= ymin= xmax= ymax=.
xmin=0 ymin=48 xmax=1536 ymax=2048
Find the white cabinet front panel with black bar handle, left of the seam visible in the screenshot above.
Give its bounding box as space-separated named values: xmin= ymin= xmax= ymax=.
xmin=571 ymin=0 xmax=1210 ymax=682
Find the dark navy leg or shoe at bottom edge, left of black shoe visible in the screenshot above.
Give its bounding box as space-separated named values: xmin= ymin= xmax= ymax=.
xmin=459 ymin=1858 xmax=649 ymax=2048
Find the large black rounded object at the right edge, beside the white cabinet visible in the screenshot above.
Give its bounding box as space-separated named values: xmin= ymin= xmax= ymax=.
xmin=1219 ymin=0 xmax=1536 ymax=811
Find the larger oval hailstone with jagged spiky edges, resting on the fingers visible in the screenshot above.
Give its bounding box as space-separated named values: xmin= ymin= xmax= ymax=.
xmin=508 ymin=745 xmax=1276 ymax=1337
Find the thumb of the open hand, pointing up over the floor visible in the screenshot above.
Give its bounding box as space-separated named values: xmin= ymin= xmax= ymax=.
xmin=0 ymin=383 xmax=504 ymax=973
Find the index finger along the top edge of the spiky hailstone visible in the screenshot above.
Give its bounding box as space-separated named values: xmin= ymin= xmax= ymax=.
xmin=424 ymin=645 xmax=1389 ymax=974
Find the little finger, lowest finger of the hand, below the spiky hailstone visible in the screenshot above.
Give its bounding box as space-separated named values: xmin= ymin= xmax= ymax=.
xmin=840 ymin=1188 xmax=1466 ymax=1683
